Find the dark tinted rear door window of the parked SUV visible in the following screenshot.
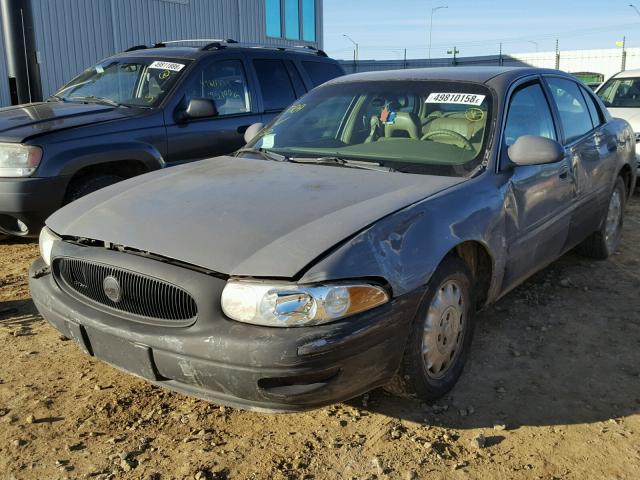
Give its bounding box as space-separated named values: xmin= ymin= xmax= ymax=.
xmin=253 ymin=60 xmax=296 ymax=112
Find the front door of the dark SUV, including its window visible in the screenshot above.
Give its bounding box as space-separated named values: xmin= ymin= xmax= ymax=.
xmin=165 ymin=55 xmax=261 ymax=164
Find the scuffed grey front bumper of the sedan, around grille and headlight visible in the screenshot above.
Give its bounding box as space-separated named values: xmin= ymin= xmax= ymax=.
xmin=29 ymin=247 xmax=421 ymax=411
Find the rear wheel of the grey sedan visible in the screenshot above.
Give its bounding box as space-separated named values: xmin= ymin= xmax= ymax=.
xmin=578 ymin=177 xmax=627 ymax=260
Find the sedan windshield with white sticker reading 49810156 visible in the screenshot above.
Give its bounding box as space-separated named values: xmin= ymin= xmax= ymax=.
xmin=248 ymin=80 xmax=492 ymax=175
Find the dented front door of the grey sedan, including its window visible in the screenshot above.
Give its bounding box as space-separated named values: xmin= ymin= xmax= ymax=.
xmin=500 ymin=80 xmax=575 ymax=288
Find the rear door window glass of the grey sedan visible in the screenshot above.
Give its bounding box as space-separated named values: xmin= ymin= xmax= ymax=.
xmin=546 ymin=77 xmax=593 ymax=143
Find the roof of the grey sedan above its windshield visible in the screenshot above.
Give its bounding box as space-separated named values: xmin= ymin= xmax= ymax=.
xmin=328 ymin=66 xmax=575 ymax=84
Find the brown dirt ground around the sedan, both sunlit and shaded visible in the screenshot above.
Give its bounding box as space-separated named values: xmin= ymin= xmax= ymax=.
xmin=0 ymin=195 xmax=640 ymax=480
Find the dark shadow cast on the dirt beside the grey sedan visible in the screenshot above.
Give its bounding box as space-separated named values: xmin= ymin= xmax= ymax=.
xmin=356 ymin=248 xmax=640 ymax=429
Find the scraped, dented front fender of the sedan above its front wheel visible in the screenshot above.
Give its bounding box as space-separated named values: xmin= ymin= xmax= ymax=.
xmin=300 ymin=176 xmax=506 ymax=300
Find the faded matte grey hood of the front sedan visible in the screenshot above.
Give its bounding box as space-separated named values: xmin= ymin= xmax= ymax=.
xmin=47 ymin=157 xmax=464 ymax=278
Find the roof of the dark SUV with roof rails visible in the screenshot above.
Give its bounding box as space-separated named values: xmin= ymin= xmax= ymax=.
xmin=113 ymin=45 xmax=335 ymax=62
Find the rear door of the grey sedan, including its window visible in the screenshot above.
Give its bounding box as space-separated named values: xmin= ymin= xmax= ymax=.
xmin=545 ymin=76 xmax=618 ymax=246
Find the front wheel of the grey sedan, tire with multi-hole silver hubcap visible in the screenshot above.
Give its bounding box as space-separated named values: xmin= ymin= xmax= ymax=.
xmin=385 ymin=257 xmax=475 ymax=401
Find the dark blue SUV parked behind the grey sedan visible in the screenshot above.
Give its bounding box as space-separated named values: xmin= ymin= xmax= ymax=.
xmin=0 ymin=40 xmax=344 ymax=236
